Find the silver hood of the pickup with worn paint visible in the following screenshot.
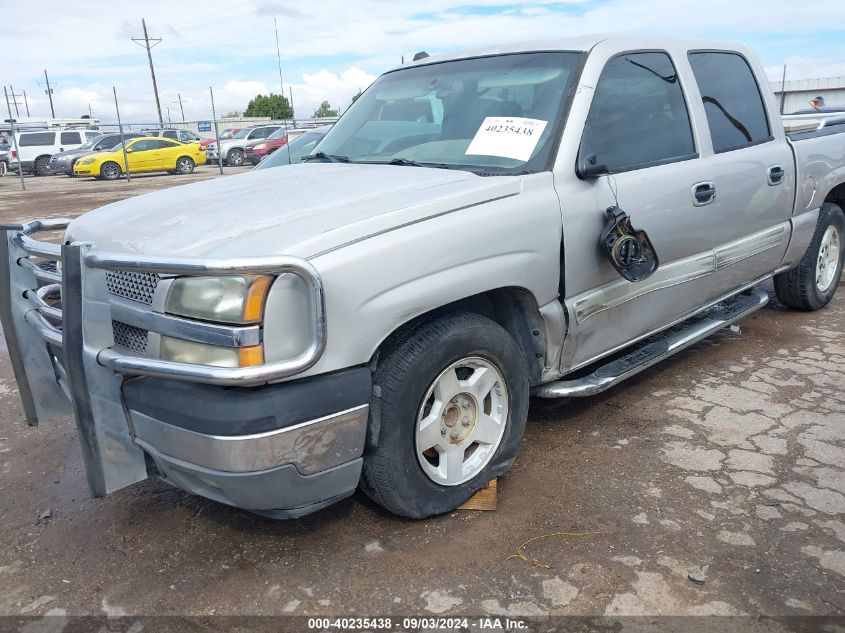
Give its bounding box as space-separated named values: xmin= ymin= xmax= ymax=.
xmin=66 ymin=163 xmax=522 ymax=258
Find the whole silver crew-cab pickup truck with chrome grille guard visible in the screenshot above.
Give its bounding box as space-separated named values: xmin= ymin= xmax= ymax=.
xmin=0 ymin=38 xmax=845 ymax=518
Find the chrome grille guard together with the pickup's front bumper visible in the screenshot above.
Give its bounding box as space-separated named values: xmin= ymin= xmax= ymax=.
xmin=0 ymin=220 xmax=342 ymax=516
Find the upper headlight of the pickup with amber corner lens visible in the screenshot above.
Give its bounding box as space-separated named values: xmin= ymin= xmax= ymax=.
xmin=164 ymin=275 xmax=272 ymax=324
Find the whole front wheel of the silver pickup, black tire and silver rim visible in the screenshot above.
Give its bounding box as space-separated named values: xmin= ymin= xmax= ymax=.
xmin=360 ymin=313 xmax=529 ymax=519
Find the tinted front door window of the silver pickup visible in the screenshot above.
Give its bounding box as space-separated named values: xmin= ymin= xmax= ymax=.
xmin=579 ymin=53 xmax=695 ymax=173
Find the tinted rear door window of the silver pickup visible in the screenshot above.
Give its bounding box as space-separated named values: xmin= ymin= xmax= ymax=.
xmin=689 ymin=52 xmax=772 ymax=154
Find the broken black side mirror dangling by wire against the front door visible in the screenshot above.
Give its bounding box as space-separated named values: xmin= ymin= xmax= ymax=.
xmin=600 ymin=206 xmax=660 ymax=281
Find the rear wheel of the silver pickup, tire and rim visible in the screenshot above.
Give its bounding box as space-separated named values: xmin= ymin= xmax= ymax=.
xmin=775 ymin=202 xmax=845 ymax=310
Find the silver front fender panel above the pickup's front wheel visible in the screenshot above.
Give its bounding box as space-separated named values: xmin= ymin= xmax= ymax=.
xmin=265 ymin=173 xmax=561 ymax=375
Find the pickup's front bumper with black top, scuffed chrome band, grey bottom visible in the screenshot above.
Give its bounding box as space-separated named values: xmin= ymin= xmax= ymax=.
xmin=123 ymin=367 xmax=371 ymax=517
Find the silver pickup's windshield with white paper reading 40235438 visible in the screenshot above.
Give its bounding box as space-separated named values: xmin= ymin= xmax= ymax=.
xmin=314 ymin=52 xmax=580 ymax=175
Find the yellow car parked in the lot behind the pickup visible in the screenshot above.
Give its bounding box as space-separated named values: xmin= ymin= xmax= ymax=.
xmin=73 ymin=136 xmax=205 ymax=180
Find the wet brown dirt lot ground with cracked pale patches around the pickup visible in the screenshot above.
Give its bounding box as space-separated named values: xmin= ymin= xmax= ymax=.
xmin=0 ymin=168 xmax=845 ymax=615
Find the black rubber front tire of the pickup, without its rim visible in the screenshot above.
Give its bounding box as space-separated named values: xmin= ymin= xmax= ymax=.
xmin=370 ymin=319 xmax=529 ymax=517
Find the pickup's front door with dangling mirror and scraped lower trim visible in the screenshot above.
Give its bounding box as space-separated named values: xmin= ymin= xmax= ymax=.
xmin=555 ymin=44 xmax=717 ymax=371
